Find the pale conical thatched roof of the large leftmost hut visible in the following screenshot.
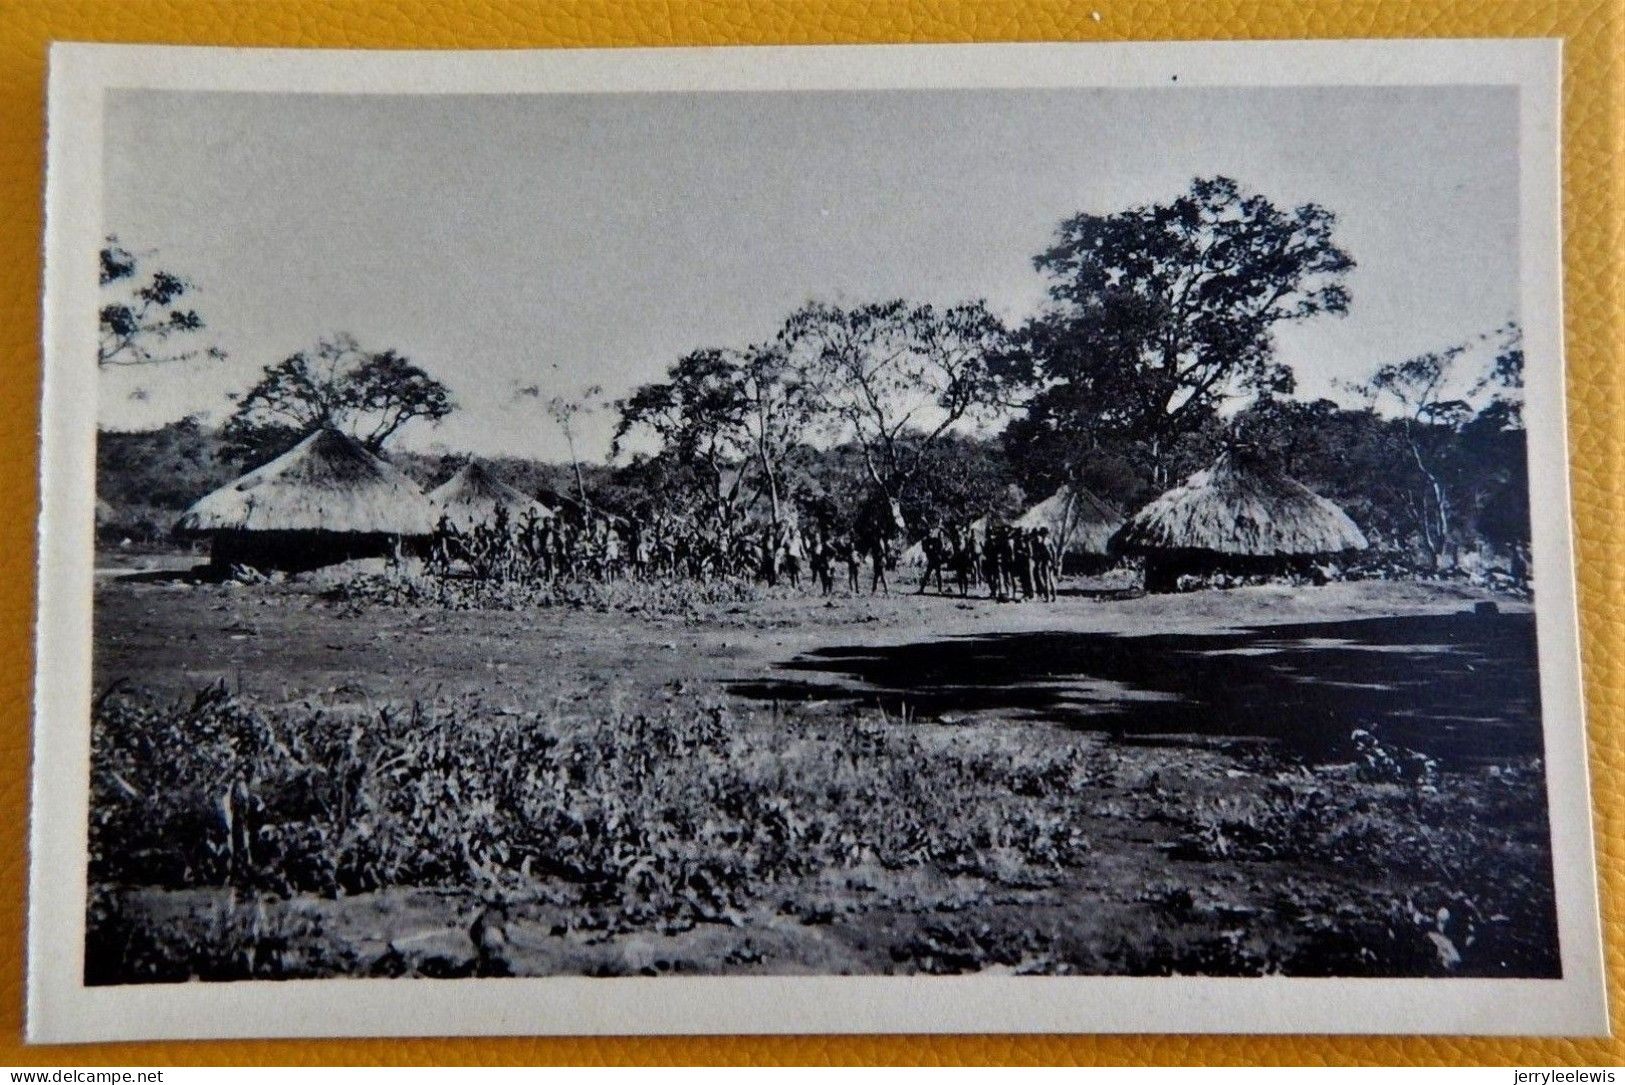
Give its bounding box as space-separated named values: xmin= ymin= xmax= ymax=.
xmin=176 ymin=429 xmax=437 ymax=534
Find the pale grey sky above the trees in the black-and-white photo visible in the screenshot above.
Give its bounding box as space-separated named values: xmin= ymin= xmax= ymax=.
xmin=99 ymin=88 xmax=1519 ymax=460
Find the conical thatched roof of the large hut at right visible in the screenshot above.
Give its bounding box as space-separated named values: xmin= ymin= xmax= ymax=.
xmin=1113 ymin=452 xmax=1367 ymax=557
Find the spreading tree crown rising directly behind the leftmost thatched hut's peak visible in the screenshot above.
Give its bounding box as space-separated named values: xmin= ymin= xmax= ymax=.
xmin=221 ymin=335 xmax=455 ymax=460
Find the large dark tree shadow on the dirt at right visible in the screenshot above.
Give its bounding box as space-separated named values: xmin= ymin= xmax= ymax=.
xmin=730 ymin=612 xmax=1542 ymax=768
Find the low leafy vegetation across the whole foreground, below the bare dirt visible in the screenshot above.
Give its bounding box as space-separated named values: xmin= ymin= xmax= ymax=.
xmin=88 ymin=685 xmax=1555 ymax=983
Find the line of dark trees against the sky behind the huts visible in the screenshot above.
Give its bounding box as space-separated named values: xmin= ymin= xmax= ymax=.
xmin=101 ymin=177 xmax=1528 ymax=567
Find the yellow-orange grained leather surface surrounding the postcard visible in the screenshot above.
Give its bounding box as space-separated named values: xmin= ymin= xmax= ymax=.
xmin=0 ymin=0 xmax=1625 ymax=1066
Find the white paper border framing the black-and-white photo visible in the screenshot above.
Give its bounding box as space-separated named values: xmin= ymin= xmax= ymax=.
xmin=28 ymin=39 xmax=1607 ymax=1043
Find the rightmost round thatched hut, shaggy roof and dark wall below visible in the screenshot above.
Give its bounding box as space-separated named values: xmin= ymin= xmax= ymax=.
xmin=1112 ymin=452 xmax=1367 ymax=591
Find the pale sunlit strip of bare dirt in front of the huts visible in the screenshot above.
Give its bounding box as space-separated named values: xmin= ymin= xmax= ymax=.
xmin=94 ymin=559 xmax=1529 ymax=702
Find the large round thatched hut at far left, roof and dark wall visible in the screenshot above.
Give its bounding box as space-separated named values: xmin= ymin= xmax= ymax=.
xmin=176 ymin=429 xmax=437 ymax=570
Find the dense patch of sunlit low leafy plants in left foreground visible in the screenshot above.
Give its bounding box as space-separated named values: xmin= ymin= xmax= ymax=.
xmin=91 ymin=685 xmax=1090 ymax=924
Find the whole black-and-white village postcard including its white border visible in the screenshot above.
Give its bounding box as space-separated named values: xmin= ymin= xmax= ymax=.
xmin=28 ymin=41 xmax=1607 ymax=1041
